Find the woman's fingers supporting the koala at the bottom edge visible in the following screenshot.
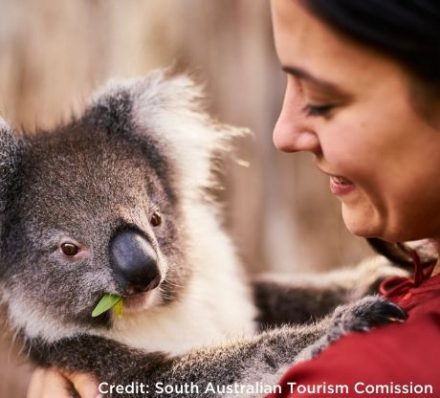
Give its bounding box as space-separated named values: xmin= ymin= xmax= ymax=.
xmin=27 ymin=368 xmax=101 ymax=398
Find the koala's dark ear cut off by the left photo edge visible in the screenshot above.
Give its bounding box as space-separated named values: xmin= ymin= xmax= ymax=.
xmin=0 ymin=118 xmax=20 ymax=236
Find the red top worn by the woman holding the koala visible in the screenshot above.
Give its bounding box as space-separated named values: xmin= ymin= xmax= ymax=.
xmin=268 ymin=260 xmax=440 ymax=398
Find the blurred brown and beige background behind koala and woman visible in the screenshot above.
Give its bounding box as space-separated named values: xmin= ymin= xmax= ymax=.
xmin=0 ymin=0 xmax=369 ymax=398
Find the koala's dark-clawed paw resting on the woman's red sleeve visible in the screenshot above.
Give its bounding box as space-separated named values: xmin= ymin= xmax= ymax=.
xmin=297 ymin=296 xmax=407 ymax=361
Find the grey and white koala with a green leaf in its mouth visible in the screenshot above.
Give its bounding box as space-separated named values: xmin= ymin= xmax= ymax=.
xmin=0 ymin=71 xmax=405 ymax=397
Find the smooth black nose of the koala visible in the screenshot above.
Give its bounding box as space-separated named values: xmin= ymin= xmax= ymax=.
xmin=110 ymin=230 xmax=160 ymax=294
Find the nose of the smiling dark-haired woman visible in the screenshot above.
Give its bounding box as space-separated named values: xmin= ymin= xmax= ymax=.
xmin=273 ymin=86 xmax=320 ymax=153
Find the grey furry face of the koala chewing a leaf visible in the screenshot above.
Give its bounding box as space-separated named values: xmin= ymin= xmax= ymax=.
xmin=0 ymin=72 xmax=222 ymax=336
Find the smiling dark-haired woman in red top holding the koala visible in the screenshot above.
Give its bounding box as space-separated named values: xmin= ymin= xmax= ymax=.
xmin=28 ymin=0 xmax=440 ymax=398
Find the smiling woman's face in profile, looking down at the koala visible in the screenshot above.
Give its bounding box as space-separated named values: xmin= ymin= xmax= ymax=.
xmin=272 ymin=0 xmax=440 ymax=241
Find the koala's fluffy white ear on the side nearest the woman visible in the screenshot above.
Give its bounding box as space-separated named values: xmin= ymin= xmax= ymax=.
xmin=90 ymin=70 xmax=246 ymax=195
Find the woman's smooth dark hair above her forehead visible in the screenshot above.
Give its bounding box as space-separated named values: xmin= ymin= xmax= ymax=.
xmin=302 ymin=0 xmax=440 ymax=87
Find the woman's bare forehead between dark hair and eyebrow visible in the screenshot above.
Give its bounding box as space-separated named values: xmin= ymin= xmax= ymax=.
xmin=271 ymin=0 xmax=408 ymax=89
